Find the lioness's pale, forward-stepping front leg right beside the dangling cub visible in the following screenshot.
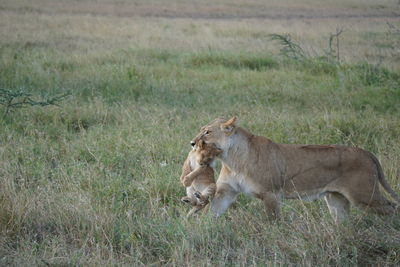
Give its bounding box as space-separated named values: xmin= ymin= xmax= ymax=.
xmin=210 ymin=183 xmax=238 ymax=217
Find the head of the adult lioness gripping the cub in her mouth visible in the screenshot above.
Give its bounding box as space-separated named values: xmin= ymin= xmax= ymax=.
xmin=190 ymin=117 xmax=236 ymax=151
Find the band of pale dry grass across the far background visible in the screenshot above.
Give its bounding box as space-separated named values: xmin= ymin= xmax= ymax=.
xmin=0 ymin=0 xmax=400 ymax=67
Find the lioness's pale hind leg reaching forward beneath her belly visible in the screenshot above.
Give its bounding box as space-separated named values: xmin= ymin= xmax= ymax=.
xmin=325 ymin=192 xmax=350 ymax=223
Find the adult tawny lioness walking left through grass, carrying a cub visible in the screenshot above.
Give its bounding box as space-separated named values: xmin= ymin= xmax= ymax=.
xmin=191 ymin=117 xmax=400 ymax=221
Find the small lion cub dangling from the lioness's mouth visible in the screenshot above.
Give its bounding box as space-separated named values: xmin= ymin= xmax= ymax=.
xmin=180 ymin=140 xmax=222 ymax=216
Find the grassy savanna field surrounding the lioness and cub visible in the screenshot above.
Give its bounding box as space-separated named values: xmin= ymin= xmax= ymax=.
xmin=0 ymin=0 xmax=400 ymax=266
